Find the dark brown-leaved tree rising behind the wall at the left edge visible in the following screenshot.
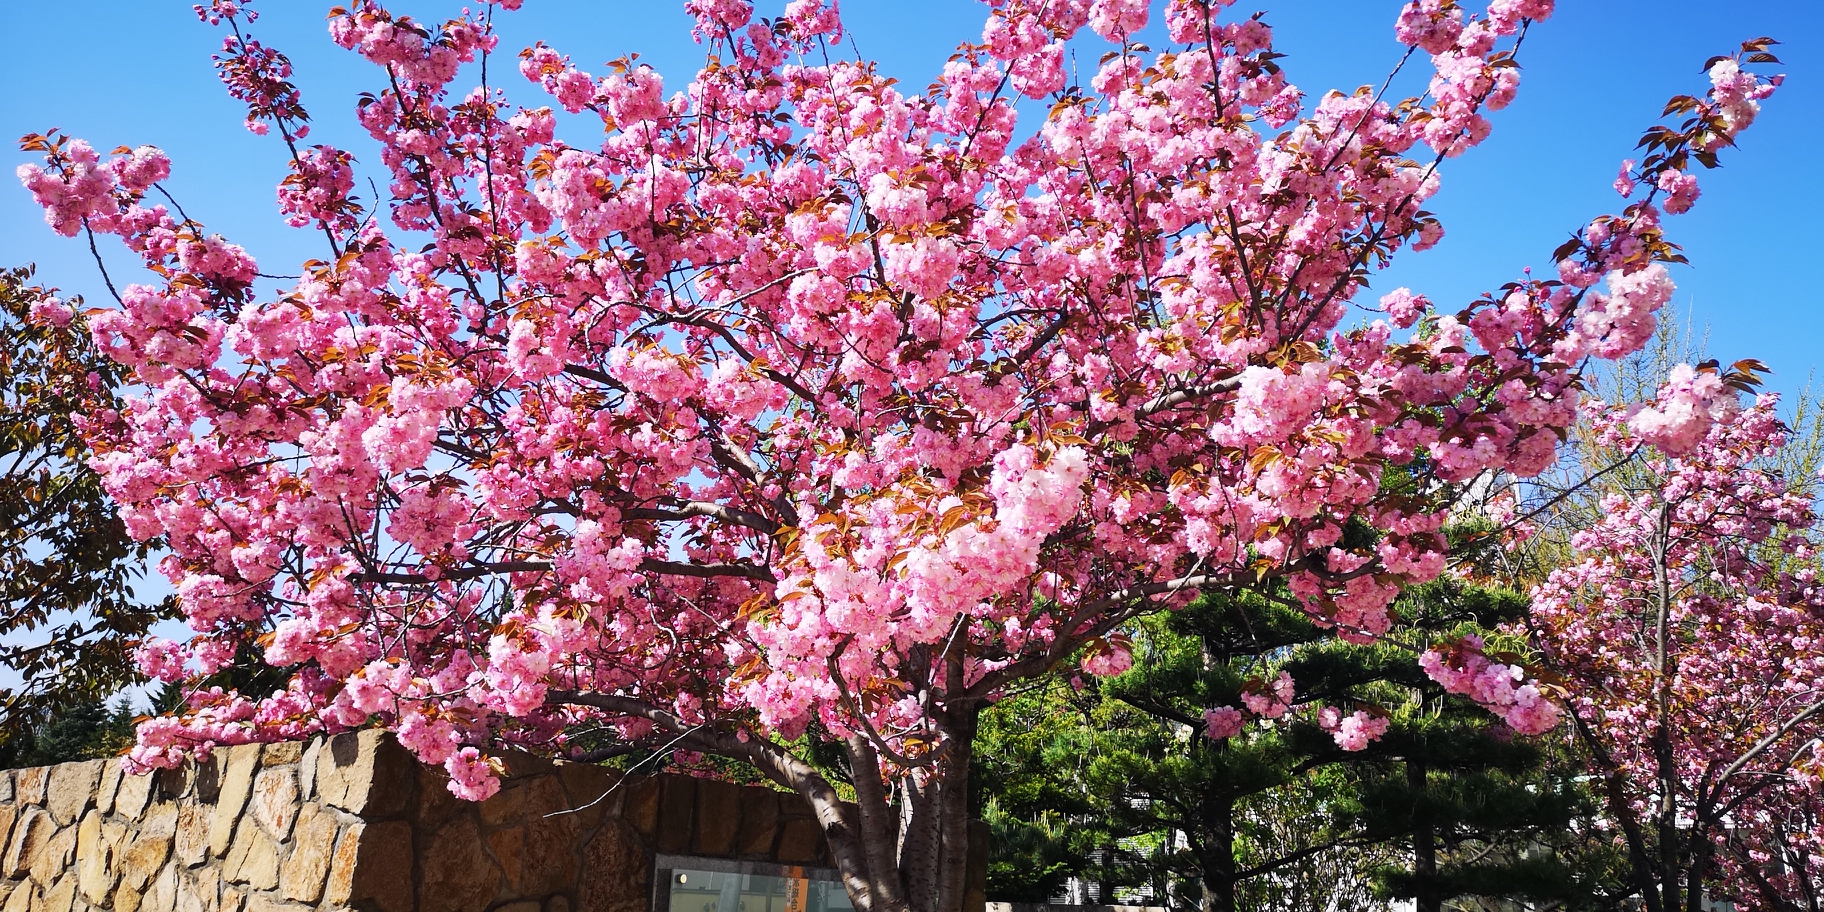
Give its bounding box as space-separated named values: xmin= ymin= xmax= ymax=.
xmin=0 ymin=266 xmax=175 ymax=741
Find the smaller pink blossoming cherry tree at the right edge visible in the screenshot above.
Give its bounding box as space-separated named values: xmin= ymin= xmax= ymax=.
xmin=1532 ymin=384 xmax=1824 ymax=910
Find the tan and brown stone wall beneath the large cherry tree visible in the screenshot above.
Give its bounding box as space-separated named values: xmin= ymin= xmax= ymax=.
xmin=0 ymin=731 xmax=985 ymax=912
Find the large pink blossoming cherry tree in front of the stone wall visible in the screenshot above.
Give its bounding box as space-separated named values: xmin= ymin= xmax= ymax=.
xmin=20 ymin=0 xmax=1773 ymax=912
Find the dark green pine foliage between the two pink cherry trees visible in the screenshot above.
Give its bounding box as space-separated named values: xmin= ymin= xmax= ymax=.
xmin=978 ymin=580 xmax=1601 ymax=912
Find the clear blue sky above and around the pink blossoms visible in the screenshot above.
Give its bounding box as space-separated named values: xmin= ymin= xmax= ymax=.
xmin=0 ymin=0 xmax=1824 ymax=390
